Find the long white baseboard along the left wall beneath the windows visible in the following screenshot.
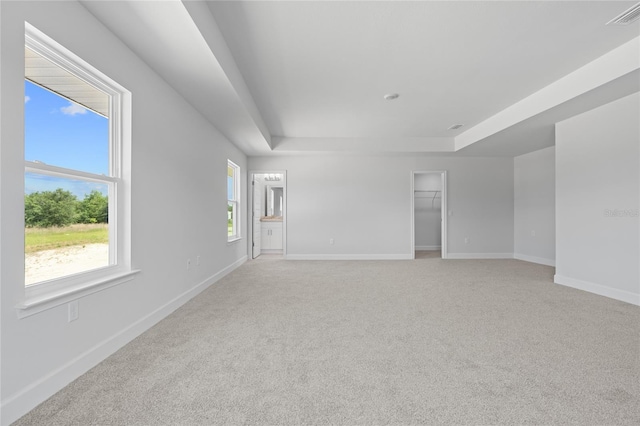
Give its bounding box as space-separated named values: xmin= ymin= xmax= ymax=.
xmin=0 ymin=256 xmax=247 ymax=426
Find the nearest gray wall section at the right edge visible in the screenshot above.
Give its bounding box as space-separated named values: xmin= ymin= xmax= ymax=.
xmin=555 ymin=93 xmax=640 ymax=304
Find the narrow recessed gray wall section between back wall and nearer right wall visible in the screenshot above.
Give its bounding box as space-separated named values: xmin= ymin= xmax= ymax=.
xmin=513 ymin=146 xmax=556 ymax=266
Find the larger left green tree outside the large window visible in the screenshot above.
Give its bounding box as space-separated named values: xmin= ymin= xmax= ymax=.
xmin=24 ymin=188 xmax=78 ymax=228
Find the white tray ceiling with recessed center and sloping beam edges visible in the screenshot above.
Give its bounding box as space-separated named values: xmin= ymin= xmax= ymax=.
xmin=84 ymin=0 xmax=640 ymax=156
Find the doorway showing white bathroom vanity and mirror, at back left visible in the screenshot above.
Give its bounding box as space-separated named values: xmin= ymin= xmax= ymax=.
xmin=249 ymin=171 xmax=287 ymax=259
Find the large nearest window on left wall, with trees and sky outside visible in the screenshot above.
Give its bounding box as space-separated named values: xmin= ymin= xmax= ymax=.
xmin=24 ymin=24 xmax=130 ymax=310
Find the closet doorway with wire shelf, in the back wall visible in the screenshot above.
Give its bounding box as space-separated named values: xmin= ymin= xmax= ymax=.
xmin=411 ymin=171 xmax=448 ymax=259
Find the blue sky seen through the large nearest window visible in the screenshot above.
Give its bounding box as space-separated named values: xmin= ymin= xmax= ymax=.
xmin=24 ymin=80 xmax=109 ymax=199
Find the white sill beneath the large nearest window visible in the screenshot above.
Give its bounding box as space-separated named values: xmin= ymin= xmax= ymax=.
xmin=16 ymin=269 xmax=140 ymax=318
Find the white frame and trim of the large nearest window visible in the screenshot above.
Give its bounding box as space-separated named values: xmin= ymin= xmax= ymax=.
xmin=16 ymin=22 xmax=139 ymax=318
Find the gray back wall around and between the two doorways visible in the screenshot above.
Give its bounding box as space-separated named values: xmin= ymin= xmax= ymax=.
xmin=249 ymin=155 xmax=513 ymax=259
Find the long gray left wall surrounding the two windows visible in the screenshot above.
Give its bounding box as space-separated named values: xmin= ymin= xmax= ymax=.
xmin=0 ymin=2 xmax=247 ymax=424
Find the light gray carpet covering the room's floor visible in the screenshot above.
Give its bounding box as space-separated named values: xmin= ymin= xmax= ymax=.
xmin=17 ymin=258 xmax=640 ymax=425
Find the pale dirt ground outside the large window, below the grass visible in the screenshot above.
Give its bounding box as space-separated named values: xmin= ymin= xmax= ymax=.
xmin=24 ymin=244 xmax=109 ymax=285
